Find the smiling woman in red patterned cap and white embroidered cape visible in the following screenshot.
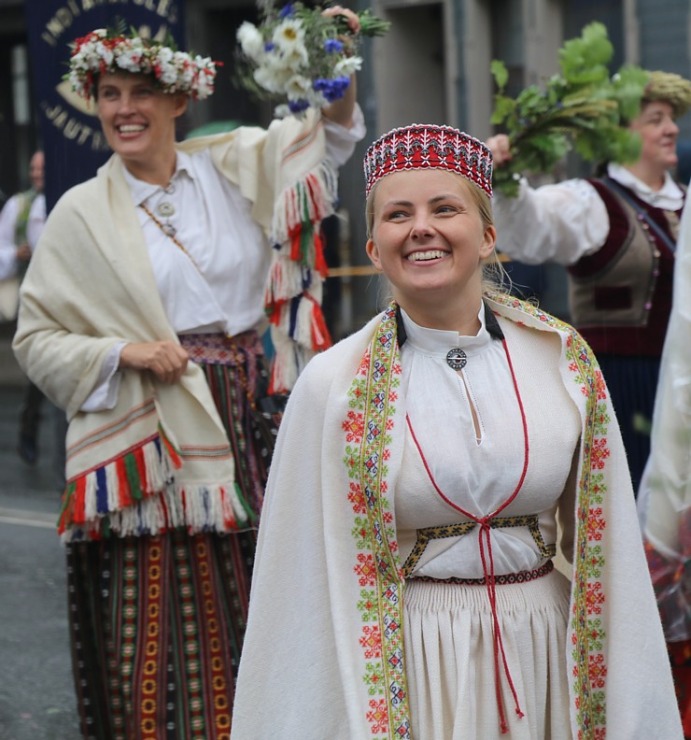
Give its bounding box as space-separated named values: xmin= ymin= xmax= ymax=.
xmin=231 ymin=124 xmax=682 ymax=740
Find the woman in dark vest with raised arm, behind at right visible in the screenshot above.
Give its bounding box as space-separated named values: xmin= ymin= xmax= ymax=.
xmin=487 ymin=72 xmax=691 ymax=492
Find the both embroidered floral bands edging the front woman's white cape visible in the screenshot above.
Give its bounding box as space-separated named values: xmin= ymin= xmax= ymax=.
xmin=342 ymin=295 xmax=611 ymax=740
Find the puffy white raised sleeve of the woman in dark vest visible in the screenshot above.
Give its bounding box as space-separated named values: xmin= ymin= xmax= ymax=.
xmin=493 ymin=179 xmax=610 ymax=265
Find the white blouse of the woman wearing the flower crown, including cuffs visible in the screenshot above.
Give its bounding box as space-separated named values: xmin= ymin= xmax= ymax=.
xmin=81 ymin=110 xmax=365 ymax=412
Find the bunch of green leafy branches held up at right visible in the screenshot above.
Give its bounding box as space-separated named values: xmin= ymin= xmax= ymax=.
xmin=491 ymin=22 xmax=649 ymax=196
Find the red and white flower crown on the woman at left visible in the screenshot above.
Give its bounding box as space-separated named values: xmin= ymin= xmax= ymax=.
xmin=65 ymin=28 xmax=218 ymax=100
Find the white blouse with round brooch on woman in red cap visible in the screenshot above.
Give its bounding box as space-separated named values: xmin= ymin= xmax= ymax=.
xmin=395 ymin=306 xmax=580 ymax=579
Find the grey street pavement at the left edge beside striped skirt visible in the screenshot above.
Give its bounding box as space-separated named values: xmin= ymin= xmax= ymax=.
xmin=0 ymin=337 xmax=80 ymax=740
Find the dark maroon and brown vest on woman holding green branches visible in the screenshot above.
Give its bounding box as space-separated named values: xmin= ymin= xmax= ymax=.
xmin=568 ymin=179 xmax=681 ymax=357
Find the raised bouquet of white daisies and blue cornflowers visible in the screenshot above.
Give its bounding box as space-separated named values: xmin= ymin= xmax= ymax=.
xmin=237 ymin=0 xmax=390 ymax=118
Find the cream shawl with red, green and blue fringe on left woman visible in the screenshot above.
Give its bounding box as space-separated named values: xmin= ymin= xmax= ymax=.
xmin=13 ymin=113 xmax=335 ymax=539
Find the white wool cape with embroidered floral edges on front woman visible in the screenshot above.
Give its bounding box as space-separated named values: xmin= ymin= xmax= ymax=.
xmin=231 ymin=297 xmax=682 ymax=740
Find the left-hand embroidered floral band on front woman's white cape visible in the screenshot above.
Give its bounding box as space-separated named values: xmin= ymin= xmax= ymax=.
xmin=343 ymin=307 xmax=411 ymax=740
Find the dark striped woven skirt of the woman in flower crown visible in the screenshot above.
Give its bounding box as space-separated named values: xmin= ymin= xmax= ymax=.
xmin=67 ymin=332 xmax=280 ymax=740
